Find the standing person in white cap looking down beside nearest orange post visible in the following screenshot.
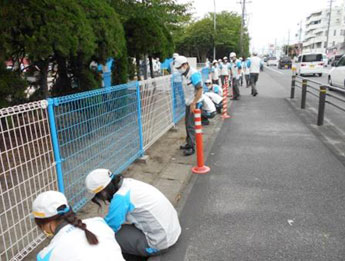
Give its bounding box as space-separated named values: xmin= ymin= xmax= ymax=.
xmin=175 ymin=56 xmax=203 ymax=156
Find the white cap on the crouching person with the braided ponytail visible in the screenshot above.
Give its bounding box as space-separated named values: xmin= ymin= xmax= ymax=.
xmin=32 ymin=190 xmax=70 ymax=218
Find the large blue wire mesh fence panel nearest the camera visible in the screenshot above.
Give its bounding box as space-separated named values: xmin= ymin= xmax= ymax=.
xmin=54 ymin=82 xmax=141 ymax=210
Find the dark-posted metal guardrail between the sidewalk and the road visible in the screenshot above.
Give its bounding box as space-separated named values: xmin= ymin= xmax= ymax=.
xmin=290 ymin=75 xmax=345 ymax=126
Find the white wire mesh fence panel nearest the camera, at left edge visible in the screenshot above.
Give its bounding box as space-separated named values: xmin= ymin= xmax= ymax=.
xmin=0 ymin=101 xmax=57 ymax=260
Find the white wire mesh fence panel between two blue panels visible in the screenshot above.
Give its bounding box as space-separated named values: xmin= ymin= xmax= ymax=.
xmin=140 ymin=75 xmax=174 ymax=150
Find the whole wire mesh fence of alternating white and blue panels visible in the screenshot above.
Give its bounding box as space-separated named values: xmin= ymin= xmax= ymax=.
xmin=0 ymin=75 xmax=185 ymax=261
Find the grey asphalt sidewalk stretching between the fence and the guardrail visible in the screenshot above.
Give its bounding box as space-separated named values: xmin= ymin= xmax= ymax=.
xmin=160 ymin=71 xmax=345 ymax=261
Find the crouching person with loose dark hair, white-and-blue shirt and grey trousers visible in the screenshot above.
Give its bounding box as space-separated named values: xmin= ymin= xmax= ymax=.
xmin=85 ymin=169 xmax=181 ymax=258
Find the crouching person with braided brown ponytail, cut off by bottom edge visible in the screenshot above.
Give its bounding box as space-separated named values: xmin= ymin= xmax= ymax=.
xmin=32 ymin=191 xmax=124 ymax=261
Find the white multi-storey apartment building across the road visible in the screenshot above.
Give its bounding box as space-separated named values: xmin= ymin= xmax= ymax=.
xmin=303 ymin=3 xmax=345 ymax=56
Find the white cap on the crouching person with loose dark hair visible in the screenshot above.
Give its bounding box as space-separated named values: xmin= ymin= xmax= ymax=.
xmin=85 ymin=169 xmax=111 ymax=194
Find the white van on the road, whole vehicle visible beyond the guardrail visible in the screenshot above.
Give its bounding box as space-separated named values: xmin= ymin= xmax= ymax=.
xmin=296 ymin=53 xmax=324 ymax=77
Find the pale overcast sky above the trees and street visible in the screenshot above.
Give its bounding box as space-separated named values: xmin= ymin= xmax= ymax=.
xmin=177 ymin=0 xmax=344 ymax=52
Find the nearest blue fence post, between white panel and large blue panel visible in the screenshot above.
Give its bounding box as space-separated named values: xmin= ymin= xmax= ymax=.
xmin=47 ymin=98 xmax=65 ymax=193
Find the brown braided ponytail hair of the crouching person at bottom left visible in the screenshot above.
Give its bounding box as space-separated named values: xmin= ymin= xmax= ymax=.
xmin=35 ymin=205 xmax=98 ymax=245
